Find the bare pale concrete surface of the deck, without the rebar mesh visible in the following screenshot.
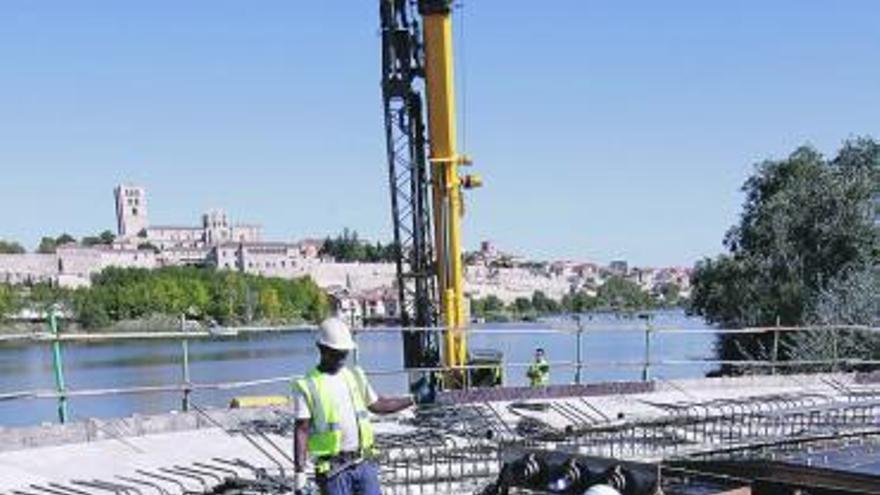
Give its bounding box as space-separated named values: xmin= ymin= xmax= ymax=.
xmin=0 ymin=374 xmax=876 ymax=495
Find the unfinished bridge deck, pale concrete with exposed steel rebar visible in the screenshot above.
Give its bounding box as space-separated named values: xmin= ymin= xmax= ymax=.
xmin=0 ymin=373 xmax=880 ymax=495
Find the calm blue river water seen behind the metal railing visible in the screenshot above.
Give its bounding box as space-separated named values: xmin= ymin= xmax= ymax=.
xmin=0 ymin=311 xmax=714 ymax=426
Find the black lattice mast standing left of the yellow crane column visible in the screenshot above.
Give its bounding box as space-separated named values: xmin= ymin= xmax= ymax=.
xmin=380 ymin=0 xmax=440 ymax=367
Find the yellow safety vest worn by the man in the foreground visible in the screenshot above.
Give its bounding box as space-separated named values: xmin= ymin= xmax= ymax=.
xmin=293 ymin=367 xmax=373 ymax=473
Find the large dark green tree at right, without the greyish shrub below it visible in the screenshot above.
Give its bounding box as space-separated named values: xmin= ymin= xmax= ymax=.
xmin=693 ymin=140 xmax=880 ymax=327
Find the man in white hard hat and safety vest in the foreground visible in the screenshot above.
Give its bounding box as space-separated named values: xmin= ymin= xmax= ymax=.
xmin=293 ymin=318 xmax=424 ymax=495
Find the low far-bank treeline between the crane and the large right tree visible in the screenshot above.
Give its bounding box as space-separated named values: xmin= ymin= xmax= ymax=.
xmin=471 ymin=277 xmax=684 ymax=321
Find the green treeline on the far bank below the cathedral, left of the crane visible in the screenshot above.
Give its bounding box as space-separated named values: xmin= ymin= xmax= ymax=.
xmin=0 ymin=267 xmax=328 ymax=328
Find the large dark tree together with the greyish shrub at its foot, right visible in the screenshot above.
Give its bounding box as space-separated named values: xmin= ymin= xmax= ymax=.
xmin=693 ymin=138 xmax=880 ymax=371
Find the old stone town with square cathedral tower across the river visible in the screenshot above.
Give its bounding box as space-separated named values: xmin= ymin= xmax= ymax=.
xmin=0 ymin=182 xmax=692 ymax=321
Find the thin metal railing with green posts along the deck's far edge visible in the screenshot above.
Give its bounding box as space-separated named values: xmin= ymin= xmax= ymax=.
xmin=0 ymin=315 xmax=880 ymax=423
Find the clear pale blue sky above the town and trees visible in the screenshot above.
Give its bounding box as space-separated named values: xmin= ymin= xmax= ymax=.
xmin=0 ymin=0 xmax=880 ymax=265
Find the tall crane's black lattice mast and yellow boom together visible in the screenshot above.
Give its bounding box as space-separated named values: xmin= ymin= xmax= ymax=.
xmin=380 ymin=0 xmax=479 ymax=386
